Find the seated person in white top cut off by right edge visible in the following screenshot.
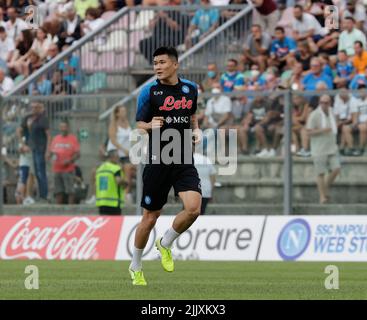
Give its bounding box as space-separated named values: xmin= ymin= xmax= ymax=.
xmin=343 ymin=85 xmax=367 ymax=156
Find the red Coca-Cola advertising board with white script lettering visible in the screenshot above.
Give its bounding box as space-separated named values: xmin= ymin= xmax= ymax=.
xmin=0 ymin=216 xmax=123 ymax=260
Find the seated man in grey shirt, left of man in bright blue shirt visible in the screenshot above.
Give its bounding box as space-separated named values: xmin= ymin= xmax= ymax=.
xmin=242 ymin=24 xmax=271 ymax=72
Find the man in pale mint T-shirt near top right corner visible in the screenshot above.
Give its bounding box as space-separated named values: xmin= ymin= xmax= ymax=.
xmin=338 ymin=17 xmax=366 ymax=57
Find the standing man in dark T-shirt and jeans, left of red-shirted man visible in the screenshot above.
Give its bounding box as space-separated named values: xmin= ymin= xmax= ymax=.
xmin=19 ymin=102 xmax=51 ymax=203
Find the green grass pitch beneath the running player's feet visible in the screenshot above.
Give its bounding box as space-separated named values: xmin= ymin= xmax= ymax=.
xmin=0 ymin=260 xmax=367 ymax=300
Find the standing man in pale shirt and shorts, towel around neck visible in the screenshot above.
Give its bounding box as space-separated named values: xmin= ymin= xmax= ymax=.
xmin=307 ymin=95 xmax=341 ymax=204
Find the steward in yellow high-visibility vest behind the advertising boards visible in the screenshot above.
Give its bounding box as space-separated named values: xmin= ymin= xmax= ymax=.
xmin=96 ymin=150 xmax=126 ymax=215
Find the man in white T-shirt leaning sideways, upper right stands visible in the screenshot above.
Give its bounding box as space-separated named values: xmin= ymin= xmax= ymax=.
xmin=292 ymin=4 xmax=325 ymax=42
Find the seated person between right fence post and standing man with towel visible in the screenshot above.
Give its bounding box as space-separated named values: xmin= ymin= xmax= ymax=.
xmin=292 ymin=95 xmax=311 ymax=158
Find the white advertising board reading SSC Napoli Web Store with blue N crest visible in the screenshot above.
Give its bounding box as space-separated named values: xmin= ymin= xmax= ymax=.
xmin=259 ymin=215 xmax=367 ymax=261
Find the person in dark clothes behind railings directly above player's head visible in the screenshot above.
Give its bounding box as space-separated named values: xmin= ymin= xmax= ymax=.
xmin=139 ymin=0 xmax=188 ymax=64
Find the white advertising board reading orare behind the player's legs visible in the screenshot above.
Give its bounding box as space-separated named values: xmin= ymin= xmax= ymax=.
xmin=116 ymin=216 xmax=265 ymax=261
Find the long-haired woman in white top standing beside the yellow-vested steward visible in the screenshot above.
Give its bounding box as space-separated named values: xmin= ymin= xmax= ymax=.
xmin=107 ymin=105 xmax=136 ymax=203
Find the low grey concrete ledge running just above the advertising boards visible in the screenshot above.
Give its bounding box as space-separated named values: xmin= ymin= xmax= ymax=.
xmin=4 ymin=203 xmax=367 ymax=216
